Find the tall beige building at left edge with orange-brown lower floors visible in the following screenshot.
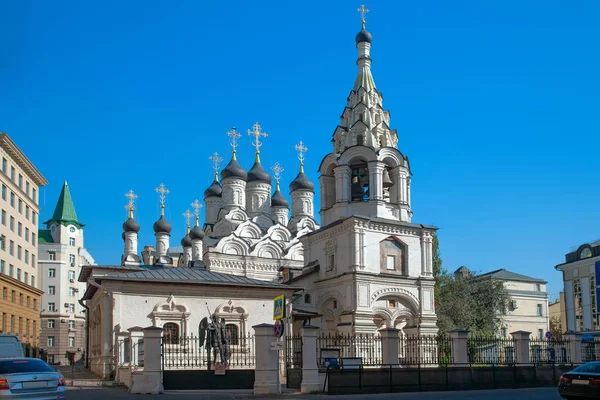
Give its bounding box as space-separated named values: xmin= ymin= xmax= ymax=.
xmin=0 ymin=133 xmax=48 ymax=345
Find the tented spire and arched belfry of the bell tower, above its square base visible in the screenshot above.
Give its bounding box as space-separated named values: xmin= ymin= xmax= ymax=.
xmin=319 ymin=10 xmax=412 ymax=225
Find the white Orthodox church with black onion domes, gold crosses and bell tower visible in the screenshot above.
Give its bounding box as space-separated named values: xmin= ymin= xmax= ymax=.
xmin=79 ymin=14 xmax=437 ymax=375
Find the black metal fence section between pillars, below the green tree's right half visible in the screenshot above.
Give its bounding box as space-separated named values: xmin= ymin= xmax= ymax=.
xmin=467 ymin=337 xmax=515 ymax=366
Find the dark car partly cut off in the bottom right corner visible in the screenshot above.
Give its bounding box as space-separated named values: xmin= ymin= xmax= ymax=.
xmin=558 ymin=361 xmax=600 ymax=400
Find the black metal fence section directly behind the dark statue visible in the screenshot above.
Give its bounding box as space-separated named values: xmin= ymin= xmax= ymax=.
xmin=161 ymin=334 xmax=255 ymax=369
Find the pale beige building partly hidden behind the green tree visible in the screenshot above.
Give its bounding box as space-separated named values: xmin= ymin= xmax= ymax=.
xmin=479 ymin=269 xmax=549 ymax=339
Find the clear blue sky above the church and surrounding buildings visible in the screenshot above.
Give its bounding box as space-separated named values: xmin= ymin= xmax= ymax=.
xmin=0 ymin=0 xmax=600 ymax=297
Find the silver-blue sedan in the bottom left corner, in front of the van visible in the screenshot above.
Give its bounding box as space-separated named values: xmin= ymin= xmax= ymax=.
xmin=0 ymin=357 xmax=67 ymax=399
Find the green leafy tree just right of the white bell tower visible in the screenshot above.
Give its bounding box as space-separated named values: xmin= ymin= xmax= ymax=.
xmin=436 ymin=271 xmax=510 ymax=336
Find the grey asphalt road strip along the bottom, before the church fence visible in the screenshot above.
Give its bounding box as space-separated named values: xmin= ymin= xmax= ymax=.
xmin=67 ymin=388 xmax=561 ymax=400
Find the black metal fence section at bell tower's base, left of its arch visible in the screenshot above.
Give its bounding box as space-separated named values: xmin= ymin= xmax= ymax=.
xmin=317 ymin=333 xmax=383 ymax=368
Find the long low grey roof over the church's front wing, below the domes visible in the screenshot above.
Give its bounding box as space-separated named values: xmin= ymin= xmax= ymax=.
xmin=79 ymin=266 xmax=300 ymax=300
